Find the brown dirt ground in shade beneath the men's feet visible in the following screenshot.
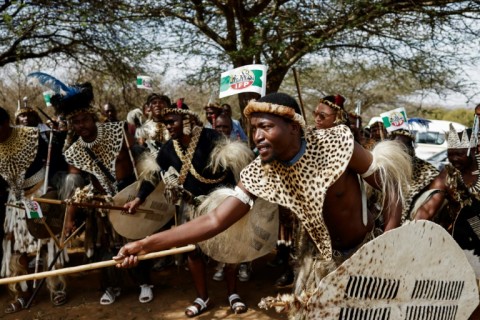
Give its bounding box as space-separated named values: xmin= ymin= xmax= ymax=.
xmin=0 ymin=253 xmax=289 ymax=320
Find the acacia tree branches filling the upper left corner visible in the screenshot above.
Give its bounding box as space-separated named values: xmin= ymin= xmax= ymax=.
xmin=0 ymin=0 xmax=155 ymax=78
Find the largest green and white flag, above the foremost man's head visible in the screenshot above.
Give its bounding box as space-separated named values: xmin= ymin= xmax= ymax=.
xmin=219 ymin=64 xmax=267 ymax=98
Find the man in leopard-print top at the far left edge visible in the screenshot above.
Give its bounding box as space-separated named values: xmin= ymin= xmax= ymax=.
xmin=0 ymin=108 xmax=66 ymax=313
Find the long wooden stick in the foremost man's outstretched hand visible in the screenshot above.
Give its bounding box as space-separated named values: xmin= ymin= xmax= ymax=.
xmin=0 ymin=244 xmax=195 ymax=285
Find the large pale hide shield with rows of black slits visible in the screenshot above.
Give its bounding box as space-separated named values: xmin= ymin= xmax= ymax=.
xmin=307 ymin=221 xmax=479 ymax=320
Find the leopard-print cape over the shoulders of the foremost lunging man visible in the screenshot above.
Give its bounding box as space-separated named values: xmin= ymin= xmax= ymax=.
xmin=240 ymin=125 xmax=354 ymax=260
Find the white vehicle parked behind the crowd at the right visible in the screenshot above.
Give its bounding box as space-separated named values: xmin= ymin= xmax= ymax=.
xmin=409 ymin=119 xmax=467 ymax=160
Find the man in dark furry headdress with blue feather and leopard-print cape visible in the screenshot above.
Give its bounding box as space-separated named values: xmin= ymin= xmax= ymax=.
xmin=51 ymin=83 xmax=153 ymax=305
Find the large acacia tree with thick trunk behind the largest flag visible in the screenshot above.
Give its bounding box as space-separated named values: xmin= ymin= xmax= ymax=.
xmin=137 ymin=0 xmax=480 ymax=110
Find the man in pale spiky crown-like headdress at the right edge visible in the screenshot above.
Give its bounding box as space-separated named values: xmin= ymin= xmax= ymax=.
xmin=412 ymin=124 xmax=480 ymax=319
